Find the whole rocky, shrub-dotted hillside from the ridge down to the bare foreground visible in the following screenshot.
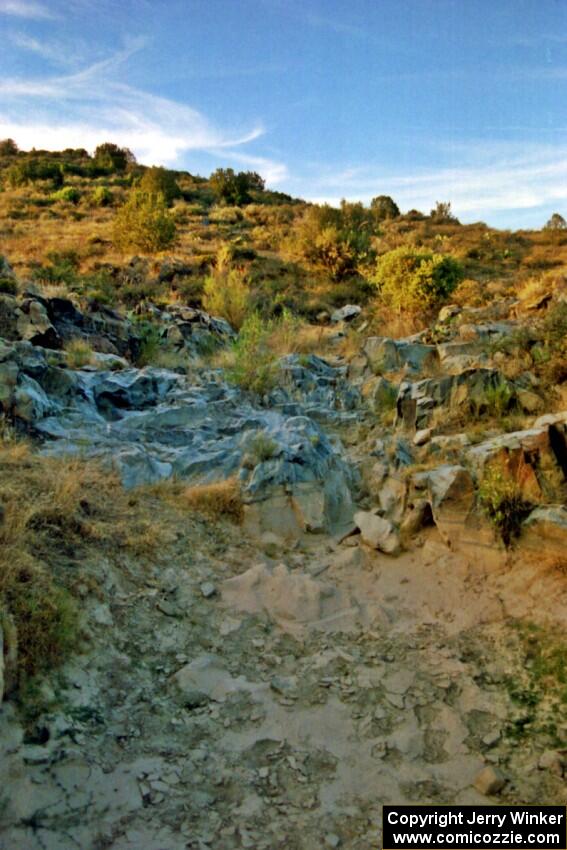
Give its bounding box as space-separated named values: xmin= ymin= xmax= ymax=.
xmin=0 ymin=143 xmax=567 ymax=850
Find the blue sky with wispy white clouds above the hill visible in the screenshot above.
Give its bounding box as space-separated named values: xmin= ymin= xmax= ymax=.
xmin=0 ymin=0 xmax=567 ymax=227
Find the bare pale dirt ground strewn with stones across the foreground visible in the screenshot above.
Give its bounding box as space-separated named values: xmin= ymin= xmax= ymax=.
xmin=0 ymin=516 xmax=567 ymax=850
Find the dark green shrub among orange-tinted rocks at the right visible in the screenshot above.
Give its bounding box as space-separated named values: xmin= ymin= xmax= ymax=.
xmin=478 ymin=467 xmax=534 ymax=547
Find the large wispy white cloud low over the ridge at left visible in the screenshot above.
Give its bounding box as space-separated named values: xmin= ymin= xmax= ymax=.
xmin=0 ymin=39 xmax=287 ymax=183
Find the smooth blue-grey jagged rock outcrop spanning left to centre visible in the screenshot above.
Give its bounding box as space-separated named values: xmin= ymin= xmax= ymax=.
xmin=0 ymin=343 xmax=357 ymax=534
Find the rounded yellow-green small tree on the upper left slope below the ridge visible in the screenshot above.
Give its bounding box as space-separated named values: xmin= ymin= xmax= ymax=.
xmin=113 ymin=190 xmax=175 ymax=253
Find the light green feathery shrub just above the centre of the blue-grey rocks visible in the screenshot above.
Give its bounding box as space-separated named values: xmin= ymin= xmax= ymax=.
xmin=226 ymin=313 xmax=278 ymax=394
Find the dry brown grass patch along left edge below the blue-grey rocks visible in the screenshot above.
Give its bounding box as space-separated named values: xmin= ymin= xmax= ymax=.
xmin=0 ymin=433 xmax=161 ymax=688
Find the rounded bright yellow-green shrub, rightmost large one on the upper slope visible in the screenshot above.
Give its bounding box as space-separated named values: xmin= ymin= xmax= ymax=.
xmin=373 ymin=246 xmax=463 ymax=313
